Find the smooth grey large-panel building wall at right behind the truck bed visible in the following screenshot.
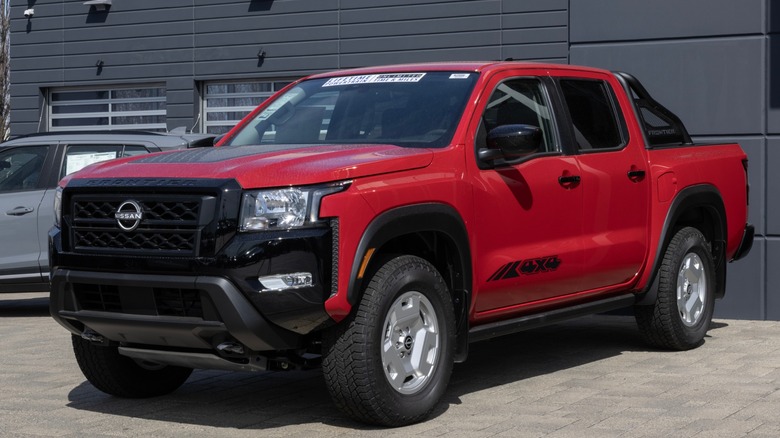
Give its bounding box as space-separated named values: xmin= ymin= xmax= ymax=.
xmin=569 ymin=0 xmax=780 ymax=320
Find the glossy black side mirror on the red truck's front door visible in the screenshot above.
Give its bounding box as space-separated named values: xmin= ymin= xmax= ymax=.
xmin=478 ymin=125 xmax=542 ymax=162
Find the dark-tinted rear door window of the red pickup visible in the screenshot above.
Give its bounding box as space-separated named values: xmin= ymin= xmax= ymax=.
xmin=560 ymin=79 xmax=623 ymax=150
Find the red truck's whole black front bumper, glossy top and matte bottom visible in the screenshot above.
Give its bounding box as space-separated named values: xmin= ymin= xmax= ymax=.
xmin=50 ymin=222 xmax=338 ymax=352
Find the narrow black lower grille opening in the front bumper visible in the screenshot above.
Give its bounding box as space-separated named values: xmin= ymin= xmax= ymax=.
xmin=73 ymin=283 xmax=203 ymax=318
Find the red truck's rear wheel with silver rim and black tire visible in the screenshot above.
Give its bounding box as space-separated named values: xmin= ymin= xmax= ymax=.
xmin=635 ymin=227 xmax=715 ymax=350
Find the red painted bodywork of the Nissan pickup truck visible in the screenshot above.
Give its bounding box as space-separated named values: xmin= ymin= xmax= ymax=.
xmin=63 ymin=62 xmax=747 ymax=325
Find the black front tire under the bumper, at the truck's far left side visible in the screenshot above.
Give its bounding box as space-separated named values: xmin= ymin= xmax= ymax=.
xmin=72 ymin=335 xmax=192 ymax=398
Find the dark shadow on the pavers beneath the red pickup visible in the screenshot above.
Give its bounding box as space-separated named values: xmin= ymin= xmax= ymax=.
xmin=68 ymin=315 xmax=676 ymax=430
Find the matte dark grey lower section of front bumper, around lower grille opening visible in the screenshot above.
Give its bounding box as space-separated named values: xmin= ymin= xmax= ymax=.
xmin=50 ymin=269 xmax=299 ymax=351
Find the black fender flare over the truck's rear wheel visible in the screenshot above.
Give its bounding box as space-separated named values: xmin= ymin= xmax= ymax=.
xmin=637 ymin=184 xmax=727 ymax=305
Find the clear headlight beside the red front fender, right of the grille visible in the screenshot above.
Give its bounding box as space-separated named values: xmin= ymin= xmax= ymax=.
xmin=241 ymin=182 xmax=348 ymax=231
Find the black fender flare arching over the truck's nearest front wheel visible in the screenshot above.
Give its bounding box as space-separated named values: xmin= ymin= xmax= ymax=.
xmin=347 ymin=203 xmax=473 ymax=361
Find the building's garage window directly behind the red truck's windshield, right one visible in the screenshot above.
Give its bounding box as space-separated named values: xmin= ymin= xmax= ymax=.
xmin=202 ymin=79 xmax=292 ymax=134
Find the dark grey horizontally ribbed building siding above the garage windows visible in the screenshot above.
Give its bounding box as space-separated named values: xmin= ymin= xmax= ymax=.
xmin=6 ymin=0 xmax=568 ymax=134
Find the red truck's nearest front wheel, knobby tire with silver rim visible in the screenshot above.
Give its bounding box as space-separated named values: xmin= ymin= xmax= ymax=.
xmin=323 ymin=256 xmax=455 ymax=426
